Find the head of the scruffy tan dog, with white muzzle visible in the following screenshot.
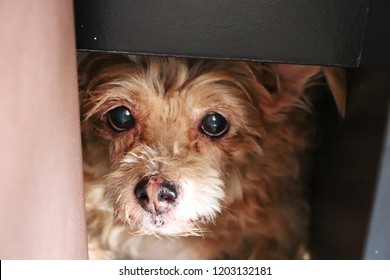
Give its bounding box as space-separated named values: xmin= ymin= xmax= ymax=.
xmin=79 ymin=54 xmax=316 ymax=236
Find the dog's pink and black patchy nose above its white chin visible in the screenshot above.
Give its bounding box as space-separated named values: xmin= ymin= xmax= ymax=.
xmin=134 ymin=177 xmax=178 ymax=214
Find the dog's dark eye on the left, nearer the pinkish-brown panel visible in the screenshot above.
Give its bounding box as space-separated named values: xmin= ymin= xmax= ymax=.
xmin=107 ymin=106 xmax=135 ymax=132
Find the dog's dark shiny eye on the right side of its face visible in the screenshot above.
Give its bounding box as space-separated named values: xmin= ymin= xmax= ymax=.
xmin=199 ymin=112 xmax=229 ymax=138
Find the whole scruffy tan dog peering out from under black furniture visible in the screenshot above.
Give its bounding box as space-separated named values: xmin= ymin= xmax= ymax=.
xmin=79 ymin=53 xmax=319 ymax=259
